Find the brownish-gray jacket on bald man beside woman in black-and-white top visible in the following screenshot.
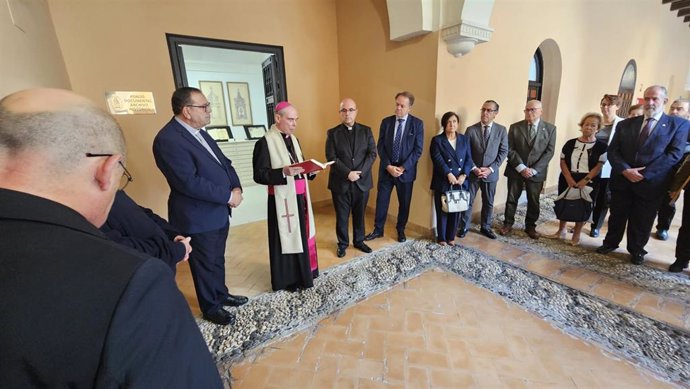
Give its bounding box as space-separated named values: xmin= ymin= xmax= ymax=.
xmin=504 ymin=119 xmax=556 ymax=182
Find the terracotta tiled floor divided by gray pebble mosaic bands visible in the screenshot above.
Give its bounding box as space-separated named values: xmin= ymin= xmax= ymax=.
xmin=177 ymin=199 xmax=690 ymax=388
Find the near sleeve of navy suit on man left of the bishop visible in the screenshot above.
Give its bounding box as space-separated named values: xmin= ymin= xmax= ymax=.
xmin=153 ymin=133 xmax=232 ymax=204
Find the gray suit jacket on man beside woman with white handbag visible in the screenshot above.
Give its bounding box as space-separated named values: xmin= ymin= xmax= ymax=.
xmin=465 ymin=122 xmax=508 ymax=182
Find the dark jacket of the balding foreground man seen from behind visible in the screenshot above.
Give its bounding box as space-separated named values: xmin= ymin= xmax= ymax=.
xmin=0 ymin=189 xmax=223 ymax=389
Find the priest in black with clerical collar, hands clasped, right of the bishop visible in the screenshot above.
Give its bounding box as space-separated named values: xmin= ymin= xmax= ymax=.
xmin=326 ymin=99 xmax=376 ymax=258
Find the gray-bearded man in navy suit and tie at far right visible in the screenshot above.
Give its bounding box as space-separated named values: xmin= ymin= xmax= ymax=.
xmin=597 ymin=85 xmax=690 ymax=265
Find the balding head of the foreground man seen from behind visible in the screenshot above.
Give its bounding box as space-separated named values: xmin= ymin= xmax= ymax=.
xmin=0 ymin=89 xmax=126 ymax=226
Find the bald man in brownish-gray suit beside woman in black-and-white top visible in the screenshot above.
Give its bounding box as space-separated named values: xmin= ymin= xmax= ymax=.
xmin=501 ymin=100 xmax=556 ymax=239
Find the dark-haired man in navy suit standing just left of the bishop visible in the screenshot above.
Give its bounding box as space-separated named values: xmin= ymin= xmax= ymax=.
xmin=153 ymin=87 xmax=247 ymax=325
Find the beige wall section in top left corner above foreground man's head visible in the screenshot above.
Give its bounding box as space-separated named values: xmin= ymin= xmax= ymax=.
xmin=0 ymin=0 xmax=70 ymax=97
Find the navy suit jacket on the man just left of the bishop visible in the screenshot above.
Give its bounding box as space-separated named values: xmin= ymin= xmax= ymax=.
xmin=153 ymin=118 xmax=241 ymax=234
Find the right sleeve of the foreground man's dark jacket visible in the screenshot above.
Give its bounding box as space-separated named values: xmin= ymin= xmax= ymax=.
xmin=95 ymin=259 xmax=223 ymax=389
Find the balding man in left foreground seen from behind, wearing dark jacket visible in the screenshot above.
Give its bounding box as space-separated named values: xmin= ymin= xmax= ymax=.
xmin=0 ymin=89 xmax=222 ymax=388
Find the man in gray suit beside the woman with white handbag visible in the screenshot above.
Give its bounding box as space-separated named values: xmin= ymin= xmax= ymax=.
xmin=458 ymin=100 xmax=508 ymax=239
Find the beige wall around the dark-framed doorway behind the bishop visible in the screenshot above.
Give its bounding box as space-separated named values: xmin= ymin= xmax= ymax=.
xmin=44 ymin=0 xmax=339 ymax=215
